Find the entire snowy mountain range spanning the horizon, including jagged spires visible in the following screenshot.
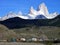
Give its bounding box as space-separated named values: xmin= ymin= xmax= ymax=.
xmin=0 ymin=3 xmax=59 ymax=21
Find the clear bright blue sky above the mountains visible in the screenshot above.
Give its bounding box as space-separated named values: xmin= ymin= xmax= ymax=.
xmin=0 ymin=0 xmax=60 ymax=17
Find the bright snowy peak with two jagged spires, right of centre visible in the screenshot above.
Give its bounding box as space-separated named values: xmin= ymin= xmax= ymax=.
xmin=28 ymin=3 xmax=58 ymax=19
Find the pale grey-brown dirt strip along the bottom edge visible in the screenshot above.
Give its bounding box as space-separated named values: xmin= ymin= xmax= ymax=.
xmin=0 ymin=42 xmax=60 ymax=45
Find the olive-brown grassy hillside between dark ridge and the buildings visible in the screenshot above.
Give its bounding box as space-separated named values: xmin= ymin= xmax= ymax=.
xmin=0 ymin=24 xmax=60 ymax=39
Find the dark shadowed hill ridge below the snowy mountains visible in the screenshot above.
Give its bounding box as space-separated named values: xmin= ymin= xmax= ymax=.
xmin=0 ymin=15 xmax=60 ymax=29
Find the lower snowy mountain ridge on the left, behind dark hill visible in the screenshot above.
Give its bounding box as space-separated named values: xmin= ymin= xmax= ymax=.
xmin=0 ymin=12 xmax=29 ymax=21
